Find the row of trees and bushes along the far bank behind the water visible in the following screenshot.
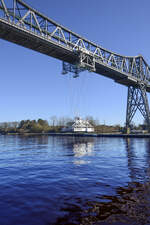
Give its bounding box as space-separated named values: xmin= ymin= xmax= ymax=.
xmin=0 ymin=116 xmax=142 ymax=133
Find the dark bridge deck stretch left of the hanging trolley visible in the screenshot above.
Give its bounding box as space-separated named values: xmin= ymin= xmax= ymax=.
xmin=0 ymin=21 xmax=76 ymax=63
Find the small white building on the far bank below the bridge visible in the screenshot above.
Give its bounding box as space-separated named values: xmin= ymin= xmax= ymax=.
xmin=62 ymin=117 xmax=94 ymax=132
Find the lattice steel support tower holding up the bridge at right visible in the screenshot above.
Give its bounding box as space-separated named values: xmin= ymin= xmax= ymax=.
xmin=126 ymin=83 xmax=150 ymax=128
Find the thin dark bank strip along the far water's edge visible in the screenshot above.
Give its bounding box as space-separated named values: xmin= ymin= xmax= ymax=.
xmin=2 ymin=133 xmax=150 ymax=138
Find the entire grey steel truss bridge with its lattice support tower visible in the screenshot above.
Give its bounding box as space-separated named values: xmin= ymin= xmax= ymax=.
xmin=0 ymin=0 xmax=150 ymax=131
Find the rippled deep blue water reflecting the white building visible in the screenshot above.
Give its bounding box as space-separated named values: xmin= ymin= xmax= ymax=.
xmin=0 ymin=135 xmax=150 ymax=225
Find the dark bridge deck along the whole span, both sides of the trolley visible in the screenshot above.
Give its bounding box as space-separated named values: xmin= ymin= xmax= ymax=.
xmin=0 ymin=19 xmax=150 ymax=92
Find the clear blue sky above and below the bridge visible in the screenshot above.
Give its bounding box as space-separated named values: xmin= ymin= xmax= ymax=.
xmin=0 ymin=0 xmax=150 ymax=124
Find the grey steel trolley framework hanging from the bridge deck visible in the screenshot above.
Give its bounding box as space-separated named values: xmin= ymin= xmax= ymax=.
xmin=62 ymin=48 xmax=95 ymax=78
